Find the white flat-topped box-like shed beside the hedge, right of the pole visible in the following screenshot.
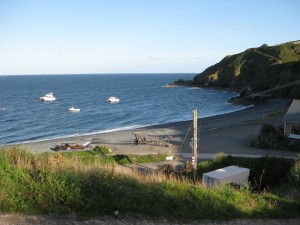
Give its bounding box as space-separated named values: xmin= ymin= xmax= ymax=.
xmin=202 ymin=165 xmax=250 ymax=187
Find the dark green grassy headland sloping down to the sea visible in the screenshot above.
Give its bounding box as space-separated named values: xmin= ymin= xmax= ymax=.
xmin=193 ymin=41 xmax=300 ymax=97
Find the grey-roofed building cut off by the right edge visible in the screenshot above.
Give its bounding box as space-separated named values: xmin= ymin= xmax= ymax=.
xmin=283 ymin=99 xmax=300 ymax=139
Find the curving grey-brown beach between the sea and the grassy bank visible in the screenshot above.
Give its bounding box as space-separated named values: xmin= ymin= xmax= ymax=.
xmin=5 ymin=99 xmax=297 ymax=158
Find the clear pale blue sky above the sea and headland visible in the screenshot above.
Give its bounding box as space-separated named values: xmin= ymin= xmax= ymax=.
xmin=0 ymin=0 xmax=300 ymax=75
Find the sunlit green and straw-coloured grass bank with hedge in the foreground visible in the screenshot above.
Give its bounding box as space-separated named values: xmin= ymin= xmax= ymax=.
xmin=0 ymin=148 xmax=300 ymax=220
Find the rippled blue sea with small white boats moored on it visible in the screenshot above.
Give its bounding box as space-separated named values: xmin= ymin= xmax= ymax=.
xmin=0 ymin=73 xmax=245 ymax=145
